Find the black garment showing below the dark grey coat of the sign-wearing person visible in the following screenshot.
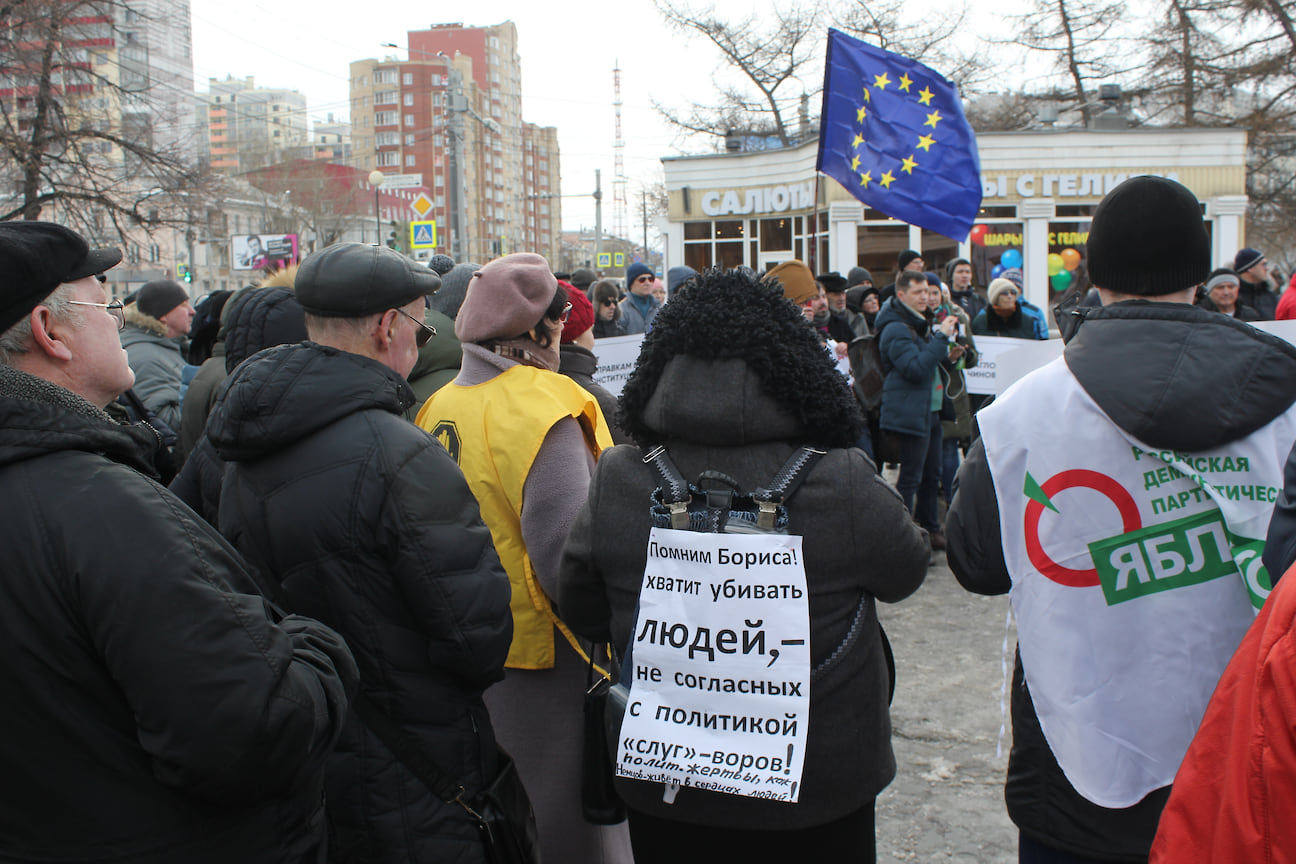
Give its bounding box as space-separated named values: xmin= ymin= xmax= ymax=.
xmin=630 ymin=802 xmax=877 ymax=864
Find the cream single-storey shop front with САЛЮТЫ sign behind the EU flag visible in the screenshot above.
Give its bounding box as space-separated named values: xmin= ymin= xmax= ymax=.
xmin=662 ymin=128 xmax=1247 ymax=327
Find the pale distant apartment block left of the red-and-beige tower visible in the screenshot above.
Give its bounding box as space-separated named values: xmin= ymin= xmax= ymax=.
xmin=207 ymin=75 xmax=310 ymax=175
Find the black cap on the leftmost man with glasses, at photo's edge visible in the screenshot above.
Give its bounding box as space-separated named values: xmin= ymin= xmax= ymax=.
xmin=0 ymin=222 xmax=122 ymax=333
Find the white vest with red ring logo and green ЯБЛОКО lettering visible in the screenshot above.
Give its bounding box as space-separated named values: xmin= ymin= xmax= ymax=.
xmin=978 ymin=358 xmax=1296 ymax=808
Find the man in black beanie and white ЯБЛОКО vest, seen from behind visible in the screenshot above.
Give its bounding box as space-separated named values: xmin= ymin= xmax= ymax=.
xmin=946 ymin=176 xmax=1296 ymax=863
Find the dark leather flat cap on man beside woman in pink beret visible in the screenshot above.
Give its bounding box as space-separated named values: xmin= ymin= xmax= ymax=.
xmin=294 ymin=244 xmax=441 ymax=317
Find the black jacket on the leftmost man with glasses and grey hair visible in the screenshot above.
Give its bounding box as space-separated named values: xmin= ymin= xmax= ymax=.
xmin=0 ymin=367 xmax=356 ymax=864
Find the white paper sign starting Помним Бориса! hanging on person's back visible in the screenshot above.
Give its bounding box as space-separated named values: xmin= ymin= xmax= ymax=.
xmin=617 ymin=529 xmax=810 ymax=802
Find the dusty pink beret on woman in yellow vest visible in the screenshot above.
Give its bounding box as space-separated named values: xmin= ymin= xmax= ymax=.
xmin=455 ymin=253 xmax=559 ymax=342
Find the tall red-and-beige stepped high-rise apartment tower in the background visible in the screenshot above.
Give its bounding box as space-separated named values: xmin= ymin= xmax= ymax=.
xmin=351 ymin=22 xmax=561 ymax=262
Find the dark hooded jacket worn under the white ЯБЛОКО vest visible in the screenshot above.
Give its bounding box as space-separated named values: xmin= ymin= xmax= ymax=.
xmin=945 ymin=301 xmax=1296 ymax=861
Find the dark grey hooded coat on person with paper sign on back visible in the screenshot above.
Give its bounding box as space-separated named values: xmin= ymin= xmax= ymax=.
xmin=559 ymin=356 xmax=929 ymax=830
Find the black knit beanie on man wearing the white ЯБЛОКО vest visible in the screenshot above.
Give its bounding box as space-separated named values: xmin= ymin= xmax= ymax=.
xmin=1089 ymin=176 xmax=1210 ymax=297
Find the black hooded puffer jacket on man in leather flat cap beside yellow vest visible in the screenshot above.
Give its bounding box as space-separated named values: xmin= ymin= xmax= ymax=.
xmin=207 ymin=342 xmax=512 ymax=864
